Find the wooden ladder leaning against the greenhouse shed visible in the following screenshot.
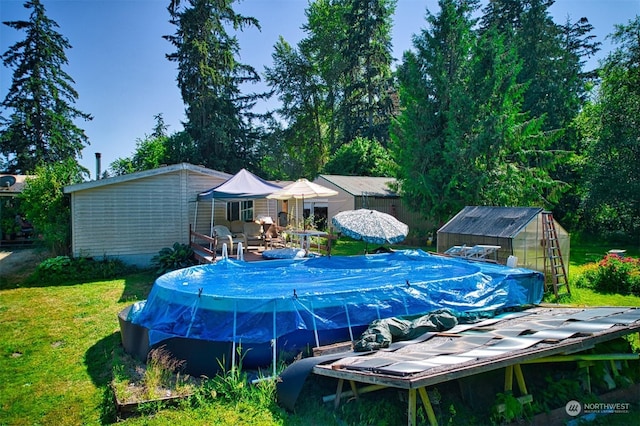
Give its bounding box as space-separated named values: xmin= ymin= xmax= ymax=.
xmin=542 ymin=212 xmax=571 ymax=298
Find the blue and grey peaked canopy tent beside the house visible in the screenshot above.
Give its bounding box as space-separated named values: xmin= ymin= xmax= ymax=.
xmin=194 ymin=169 xmax=282 ymax=233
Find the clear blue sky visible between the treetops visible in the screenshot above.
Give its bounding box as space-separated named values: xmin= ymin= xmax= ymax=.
xmin=0 ymin=0 xmax=640 ymax=178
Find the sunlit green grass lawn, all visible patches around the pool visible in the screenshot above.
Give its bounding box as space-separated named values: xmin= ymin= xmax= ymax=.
xmin=0 ymin=241 xmax=640 ymax=425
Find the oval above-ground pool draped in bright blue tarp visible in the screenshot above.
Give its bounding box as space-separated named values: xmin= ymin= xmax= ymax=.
xmin=120 ymin=250 xmax=544 ymax=374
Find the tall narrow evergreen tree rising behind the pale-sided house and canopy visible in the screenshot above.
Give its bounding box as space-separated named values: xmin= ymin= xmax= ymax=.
xmin=165 ymin=0 xmax=260 ymax=172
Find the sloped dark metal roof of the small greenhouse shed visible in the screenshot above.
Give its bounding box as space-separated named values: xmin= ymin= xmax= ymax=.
xmin=438 ymin=206 xmax=542 ymax=238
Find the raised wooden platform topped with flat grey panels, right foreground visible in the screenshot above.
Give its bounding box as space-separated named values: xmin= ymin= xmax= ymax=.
xmin=313 ymin=307 xmax=640 ymax=425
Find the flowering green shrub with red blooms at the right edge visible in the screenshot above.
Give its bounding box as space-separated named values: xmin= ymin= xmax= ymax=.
xmin=576 ymin=254 xmax=640 ymax=296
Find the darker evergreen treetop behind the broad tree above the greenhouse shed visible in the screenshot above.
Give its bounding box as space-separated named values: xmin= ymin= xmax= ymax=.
xmin=481 ymin=0 xmax=599 ymax=133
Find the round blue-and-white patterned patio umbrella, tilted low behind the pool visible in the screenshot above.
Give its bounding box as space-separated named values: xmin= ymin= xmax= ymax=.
xmin=331 ymin=209 xmax=409 ymax=251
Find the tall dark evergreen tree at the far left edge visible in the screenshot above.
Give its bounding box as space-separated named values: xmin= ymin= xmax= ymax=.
xmin=0 ymin=0 xmax=91 ymax=173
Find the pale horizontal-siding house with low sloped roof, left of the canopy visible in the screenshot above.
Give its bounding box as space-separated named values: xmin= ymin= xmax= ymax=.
xmin=64 ymin=163 xmax=231 ymax=265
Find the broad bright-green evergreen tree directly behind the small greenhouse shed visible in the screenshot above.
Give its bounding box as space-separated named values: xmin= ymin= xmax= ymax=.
xmin=393 ymin=0 xmax=562 ymax=224
